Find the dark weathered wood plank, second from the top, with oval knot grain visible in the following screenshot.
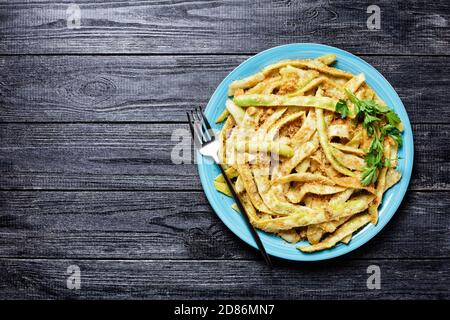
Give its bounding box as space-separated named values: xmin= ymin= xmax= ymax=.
xmin=0 ymin=56 xmax=450 ymax=123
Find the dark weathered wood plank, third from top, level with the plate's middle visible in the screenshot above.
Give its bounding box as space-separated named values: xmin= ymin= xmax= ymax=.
xmin=0 ymin=123 xmax=450 ymax=190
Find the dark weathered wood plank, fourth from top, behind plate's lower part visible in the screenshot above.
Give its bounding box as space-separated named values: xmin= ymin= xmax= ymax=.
xmin=0 ymin=191 xmax=450 ymax=260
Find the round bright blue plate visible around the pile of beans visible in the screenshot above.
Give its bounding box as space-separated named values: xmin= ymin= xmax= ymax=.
xmin=197 ymin=43 xmax=414 ymax=261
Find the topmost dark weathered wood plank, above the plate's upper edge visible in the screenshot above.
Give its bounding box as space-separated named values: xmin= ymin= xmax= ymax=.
xmin=0 ymin=0 xmax=450 ymax=54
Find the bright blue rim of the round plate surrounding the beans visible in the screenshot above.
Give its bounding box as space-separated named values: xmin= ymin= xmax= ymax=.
xmin=196 ymin=43 xmax=414 ymax=261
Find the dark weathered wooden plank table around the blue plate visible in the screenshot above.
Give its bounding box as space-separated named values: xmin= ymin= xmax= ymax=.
xmin=0 ymin=0 xmax=450 ymax=299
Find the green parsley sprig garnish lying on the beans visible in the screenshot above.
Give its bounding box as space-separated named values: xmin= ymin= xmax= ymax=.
xmin=336 ymin=90 xmax=402 ymax=186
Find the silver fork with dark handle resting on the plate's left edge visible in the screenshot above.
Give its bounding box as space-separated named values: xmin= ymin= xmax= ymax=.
xmin=186 ymin=108 xmax=272 ymax=268
